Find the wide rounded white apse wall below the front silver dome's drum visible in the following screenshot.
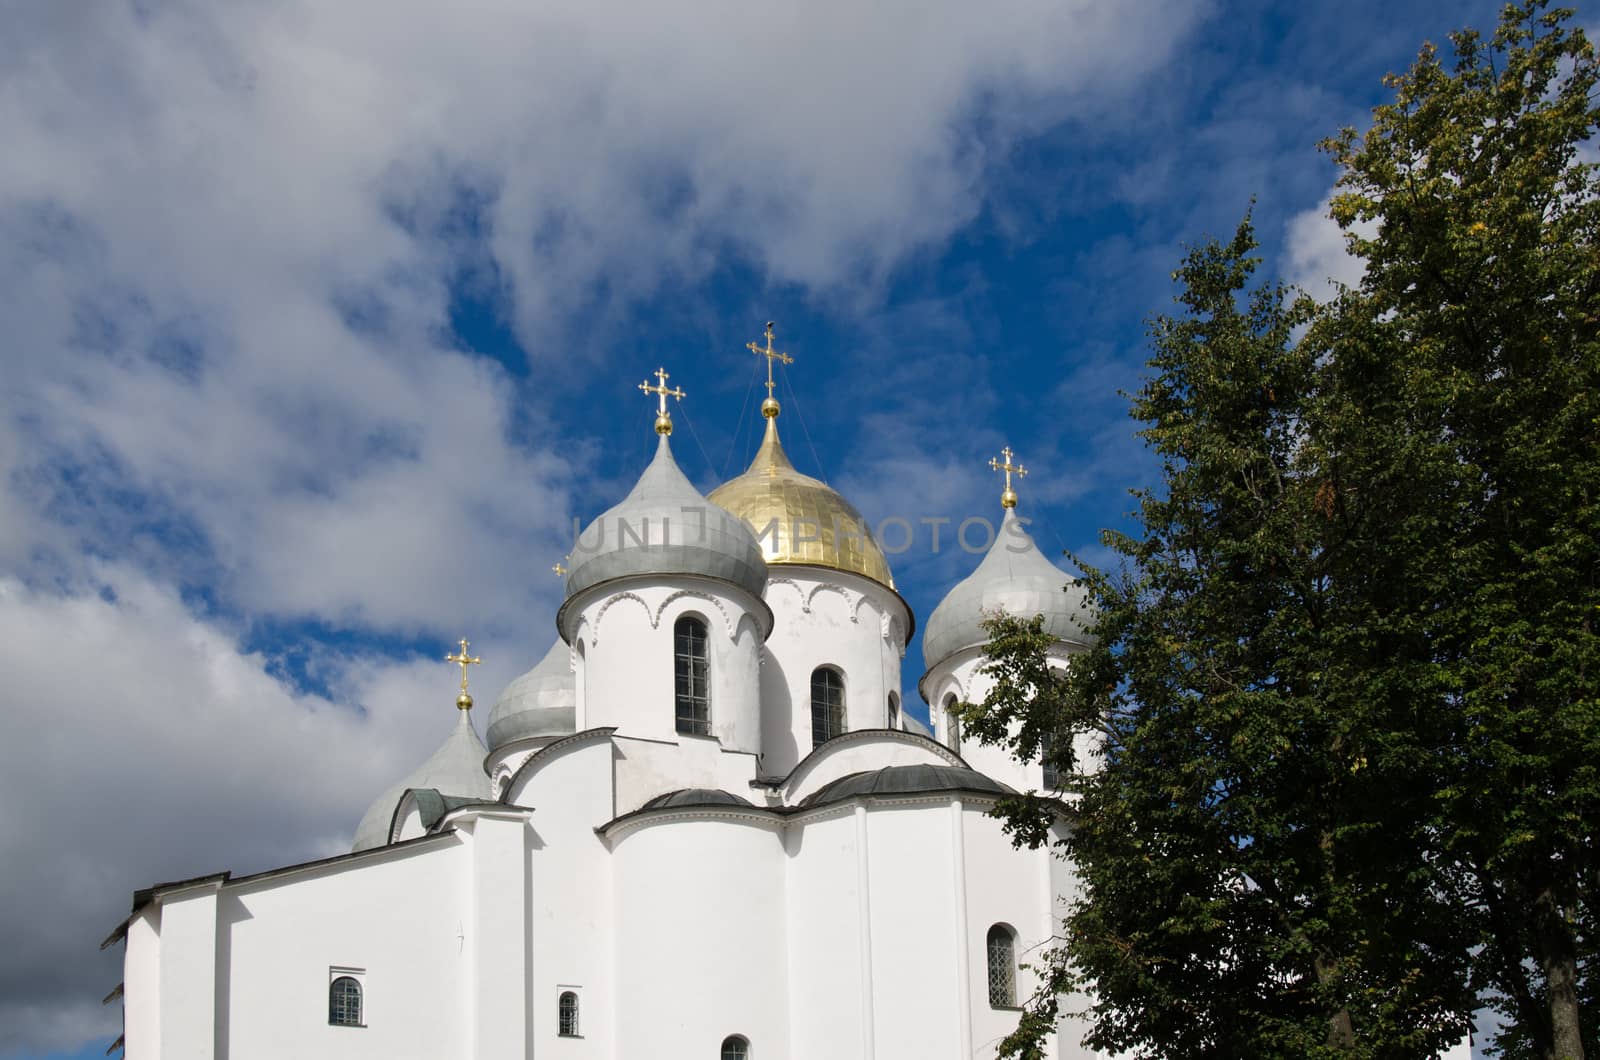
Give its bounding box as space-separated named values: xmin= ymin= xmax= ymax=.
xmin=613 ymin=817 xmax=790 ymax=1060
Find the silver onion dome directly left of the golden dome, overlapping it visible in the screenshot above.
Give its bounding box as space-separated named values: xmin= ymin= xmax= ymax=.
xmin=566 ymin=434 xmax=766 ymax=599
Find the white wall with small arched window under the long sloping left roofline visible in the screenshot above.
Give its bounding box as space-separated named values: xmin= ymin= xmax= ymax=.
xmin=220 ymin=836 xmax=475 ymax=1060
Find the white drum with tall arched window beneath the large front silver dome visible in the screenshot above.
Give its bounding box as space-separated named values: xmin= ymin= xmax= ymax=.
xmin=573 ymin=576 xmax=766 ymax=754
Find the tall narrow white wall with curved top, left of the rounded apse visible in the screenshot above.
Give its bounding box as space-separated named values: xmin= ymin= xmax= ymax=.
xmin=518 ymin=738 xmax=621 ymax=1060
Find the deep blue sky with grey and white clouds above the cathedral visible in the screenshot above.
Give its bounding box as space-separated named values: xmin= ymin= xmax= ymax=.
xmin=0 ymin=0 xmax=1496 ymax=1055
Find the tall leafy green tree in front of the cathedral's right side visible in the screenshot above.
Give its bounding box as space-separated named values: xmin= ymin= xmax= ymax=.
xmin=965 ymin=0 xmax=1600 ymax=1058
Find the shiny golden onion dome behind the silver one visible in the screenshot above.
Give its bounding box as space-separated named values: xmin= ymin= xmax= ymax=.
xmin=707 ymin=409 xmax=894 ymax=589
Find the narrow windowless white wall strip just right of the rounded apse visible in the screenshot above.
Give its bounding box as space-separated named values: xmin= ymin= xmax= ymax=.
xmin=784 ymin=805 xmax=870 ymax=1060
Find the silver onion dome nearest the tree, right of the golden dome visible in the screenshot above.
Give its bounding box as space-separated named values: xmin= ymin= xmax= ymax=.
xmin=922 ymin=505 xmax=1091 ymax=669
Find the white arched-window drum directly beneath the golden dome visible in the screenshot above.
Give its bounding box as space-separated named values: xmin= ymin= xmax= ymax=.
xmin=760 ymin=564 xmax=910 ymax=777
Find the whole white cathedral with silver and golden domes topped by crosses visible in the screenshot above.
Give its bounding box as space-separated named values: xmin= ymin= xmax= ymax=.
xmin=107 ymin=330 xmax=1094 ymax=1060
